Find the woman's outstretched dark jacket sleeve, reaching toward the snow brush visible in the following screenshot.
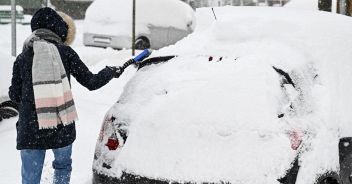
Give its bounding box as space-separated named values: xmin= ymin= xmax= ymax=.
xmin=69 ymin=48 xmax=114 ymax=90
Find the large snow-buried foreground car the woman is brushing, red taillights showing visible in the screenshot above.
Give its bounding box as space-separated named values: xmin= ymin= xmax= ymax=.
xmin=93 ymin=7 xmax=352 ymax=184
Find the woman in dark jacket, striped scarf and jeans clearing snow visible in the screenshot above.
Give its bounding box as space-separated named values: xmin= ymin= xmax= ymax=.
xmin=9 ymin=8 xmax=123 ymax=184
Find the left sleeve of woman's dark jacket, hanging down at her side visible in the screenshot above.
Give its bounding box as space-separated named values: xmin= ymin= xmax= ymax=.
xmin=9 ymin=56 xmax=22 ymax=104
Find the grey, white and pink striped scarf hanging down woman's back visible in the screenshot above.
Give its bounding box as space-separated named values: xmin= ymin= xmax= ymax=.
xmin=32 ymin=39 xmax=78 ymax=129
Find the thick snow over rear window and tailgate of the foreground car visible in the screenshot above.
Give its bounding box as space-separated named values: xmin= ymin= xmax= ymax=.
xmin=108 ymin=56 xmax=293 ymax=183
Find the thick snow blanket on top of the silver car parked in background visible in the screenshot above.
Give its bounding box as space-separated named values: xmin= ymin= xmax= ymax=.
xmin=84 ymin=0 xmax=194 ymax=36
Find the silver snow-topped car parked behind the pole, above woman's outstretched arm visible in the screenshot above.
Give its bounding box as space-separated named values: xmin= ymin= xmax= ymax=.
xmin=83 ymin=0 xmax=195 ymax=49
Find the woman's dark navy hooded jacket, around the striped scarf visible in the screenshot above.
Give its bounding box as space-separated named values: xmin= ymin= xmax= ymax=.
xmin=9 ymin=8 xmax=114 ymax=150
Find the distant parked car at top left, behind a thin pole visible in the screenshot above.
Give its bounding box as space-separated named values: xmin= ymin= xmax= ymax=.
xmin=0 ymin=5 xmax=32 ymax=25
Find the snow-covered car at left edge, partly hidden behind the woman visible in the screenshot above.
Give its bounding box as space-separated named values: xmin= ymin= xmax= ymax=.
xmin=0 ymin=52 xmax=18 ymax=121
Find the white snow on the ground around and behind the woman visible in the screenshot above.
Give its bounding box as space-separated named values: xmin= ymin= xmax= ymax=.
xmin=0 ymin=21 xmax=136 ymax=184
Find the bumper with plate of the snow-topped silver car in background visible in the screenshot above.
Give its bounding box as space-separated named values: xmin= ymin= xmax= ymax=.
xmin=83 ymin=33 xmax=132 ymax=49
